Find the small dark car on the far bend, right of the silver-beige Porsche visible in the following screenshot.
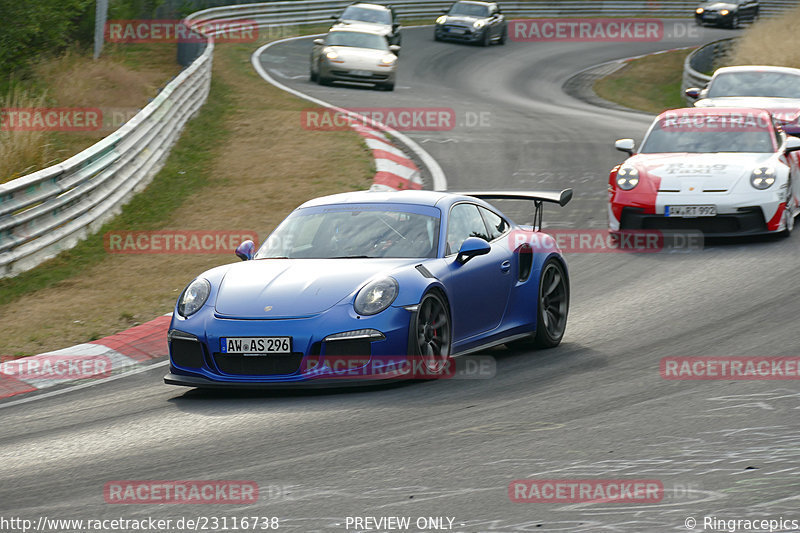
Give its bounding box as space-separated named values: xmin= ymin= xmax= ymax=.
xmin=433 ymin=0 xmax=508 ymax=46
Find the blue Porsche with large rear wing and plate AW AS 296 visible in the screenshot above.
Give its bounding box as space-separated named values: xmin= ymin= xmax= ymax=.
xmin=165 ymin=189 xmax=572 ymax=387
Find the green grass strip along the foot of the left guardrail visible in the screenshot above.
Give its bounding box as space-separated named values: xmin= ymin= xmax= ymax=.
xmin=0 ymin=77 xmax=234 ymax=305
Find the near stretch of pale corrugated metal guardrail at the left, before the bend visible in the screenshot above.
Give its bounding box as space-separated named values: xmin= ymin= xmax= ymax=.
xmin=0 ymin=32 xmax=213 ymax=277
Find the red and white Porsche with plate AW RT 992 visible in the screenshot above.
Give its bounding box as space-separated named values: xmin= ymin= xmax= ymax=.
xmin=608 ymin=108 xmax=800 ymax=237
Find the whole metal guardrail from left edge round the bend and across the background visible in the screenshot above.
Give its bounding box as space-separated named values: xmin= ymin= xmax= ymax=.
xmin=0 ymin=0 xmax=797 ymax=277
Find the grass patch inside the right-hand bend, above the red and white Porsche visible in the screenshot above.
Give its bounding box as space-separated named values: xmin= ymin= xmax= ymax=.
xmin=594 ymin=50 xmax=691 ymax=113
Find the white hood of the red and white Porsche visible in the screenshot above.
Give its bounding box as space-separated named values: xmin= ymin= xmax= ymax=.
xmin=625 ymin=153 xmax=775 ymax=192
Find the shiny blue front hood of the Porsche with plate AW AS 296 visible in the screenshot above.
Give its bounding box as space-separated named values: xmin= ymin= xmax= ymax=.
xmin=215 ymin=259 xmax=419 ymax=318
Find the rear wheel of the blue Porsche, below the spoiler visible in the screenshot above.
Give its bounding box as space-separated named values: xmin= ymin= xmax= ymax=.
xmin=533 ymin=259 xmax=569 ymax=348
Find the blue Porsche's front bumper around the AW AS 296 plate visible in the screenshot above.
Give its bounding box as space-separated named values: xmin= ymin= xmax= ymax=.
xmin=164 ymin=303 xmax=414 ymax=387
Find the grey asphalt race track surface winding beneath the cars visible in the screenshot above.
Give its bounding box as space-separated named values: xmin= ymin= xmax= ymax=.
xmin=0 ymin=21 xmax=800 ymax=532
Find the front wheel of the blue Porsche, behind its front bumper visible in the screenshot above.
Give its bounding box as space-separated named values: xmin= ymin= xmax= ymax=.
xmin=408 ymin=291 xmax=452 ymax=373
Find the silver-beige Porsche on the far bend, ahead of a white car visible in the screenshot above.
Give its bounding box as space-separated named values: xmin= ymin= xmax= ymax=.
xmin=309 ymin=28 xmax=400 ymax=91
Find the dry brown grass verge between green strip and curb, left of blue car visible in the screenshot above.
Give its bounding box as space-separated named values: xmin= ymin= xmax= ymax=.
xmin=0 ymin=39 xmax=373 ymax=355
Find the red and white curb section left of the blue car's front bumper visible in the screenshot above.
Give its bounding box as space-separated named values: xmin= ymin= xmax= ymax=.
xmin=0 ymin=315 xmax=171 ymax=398
